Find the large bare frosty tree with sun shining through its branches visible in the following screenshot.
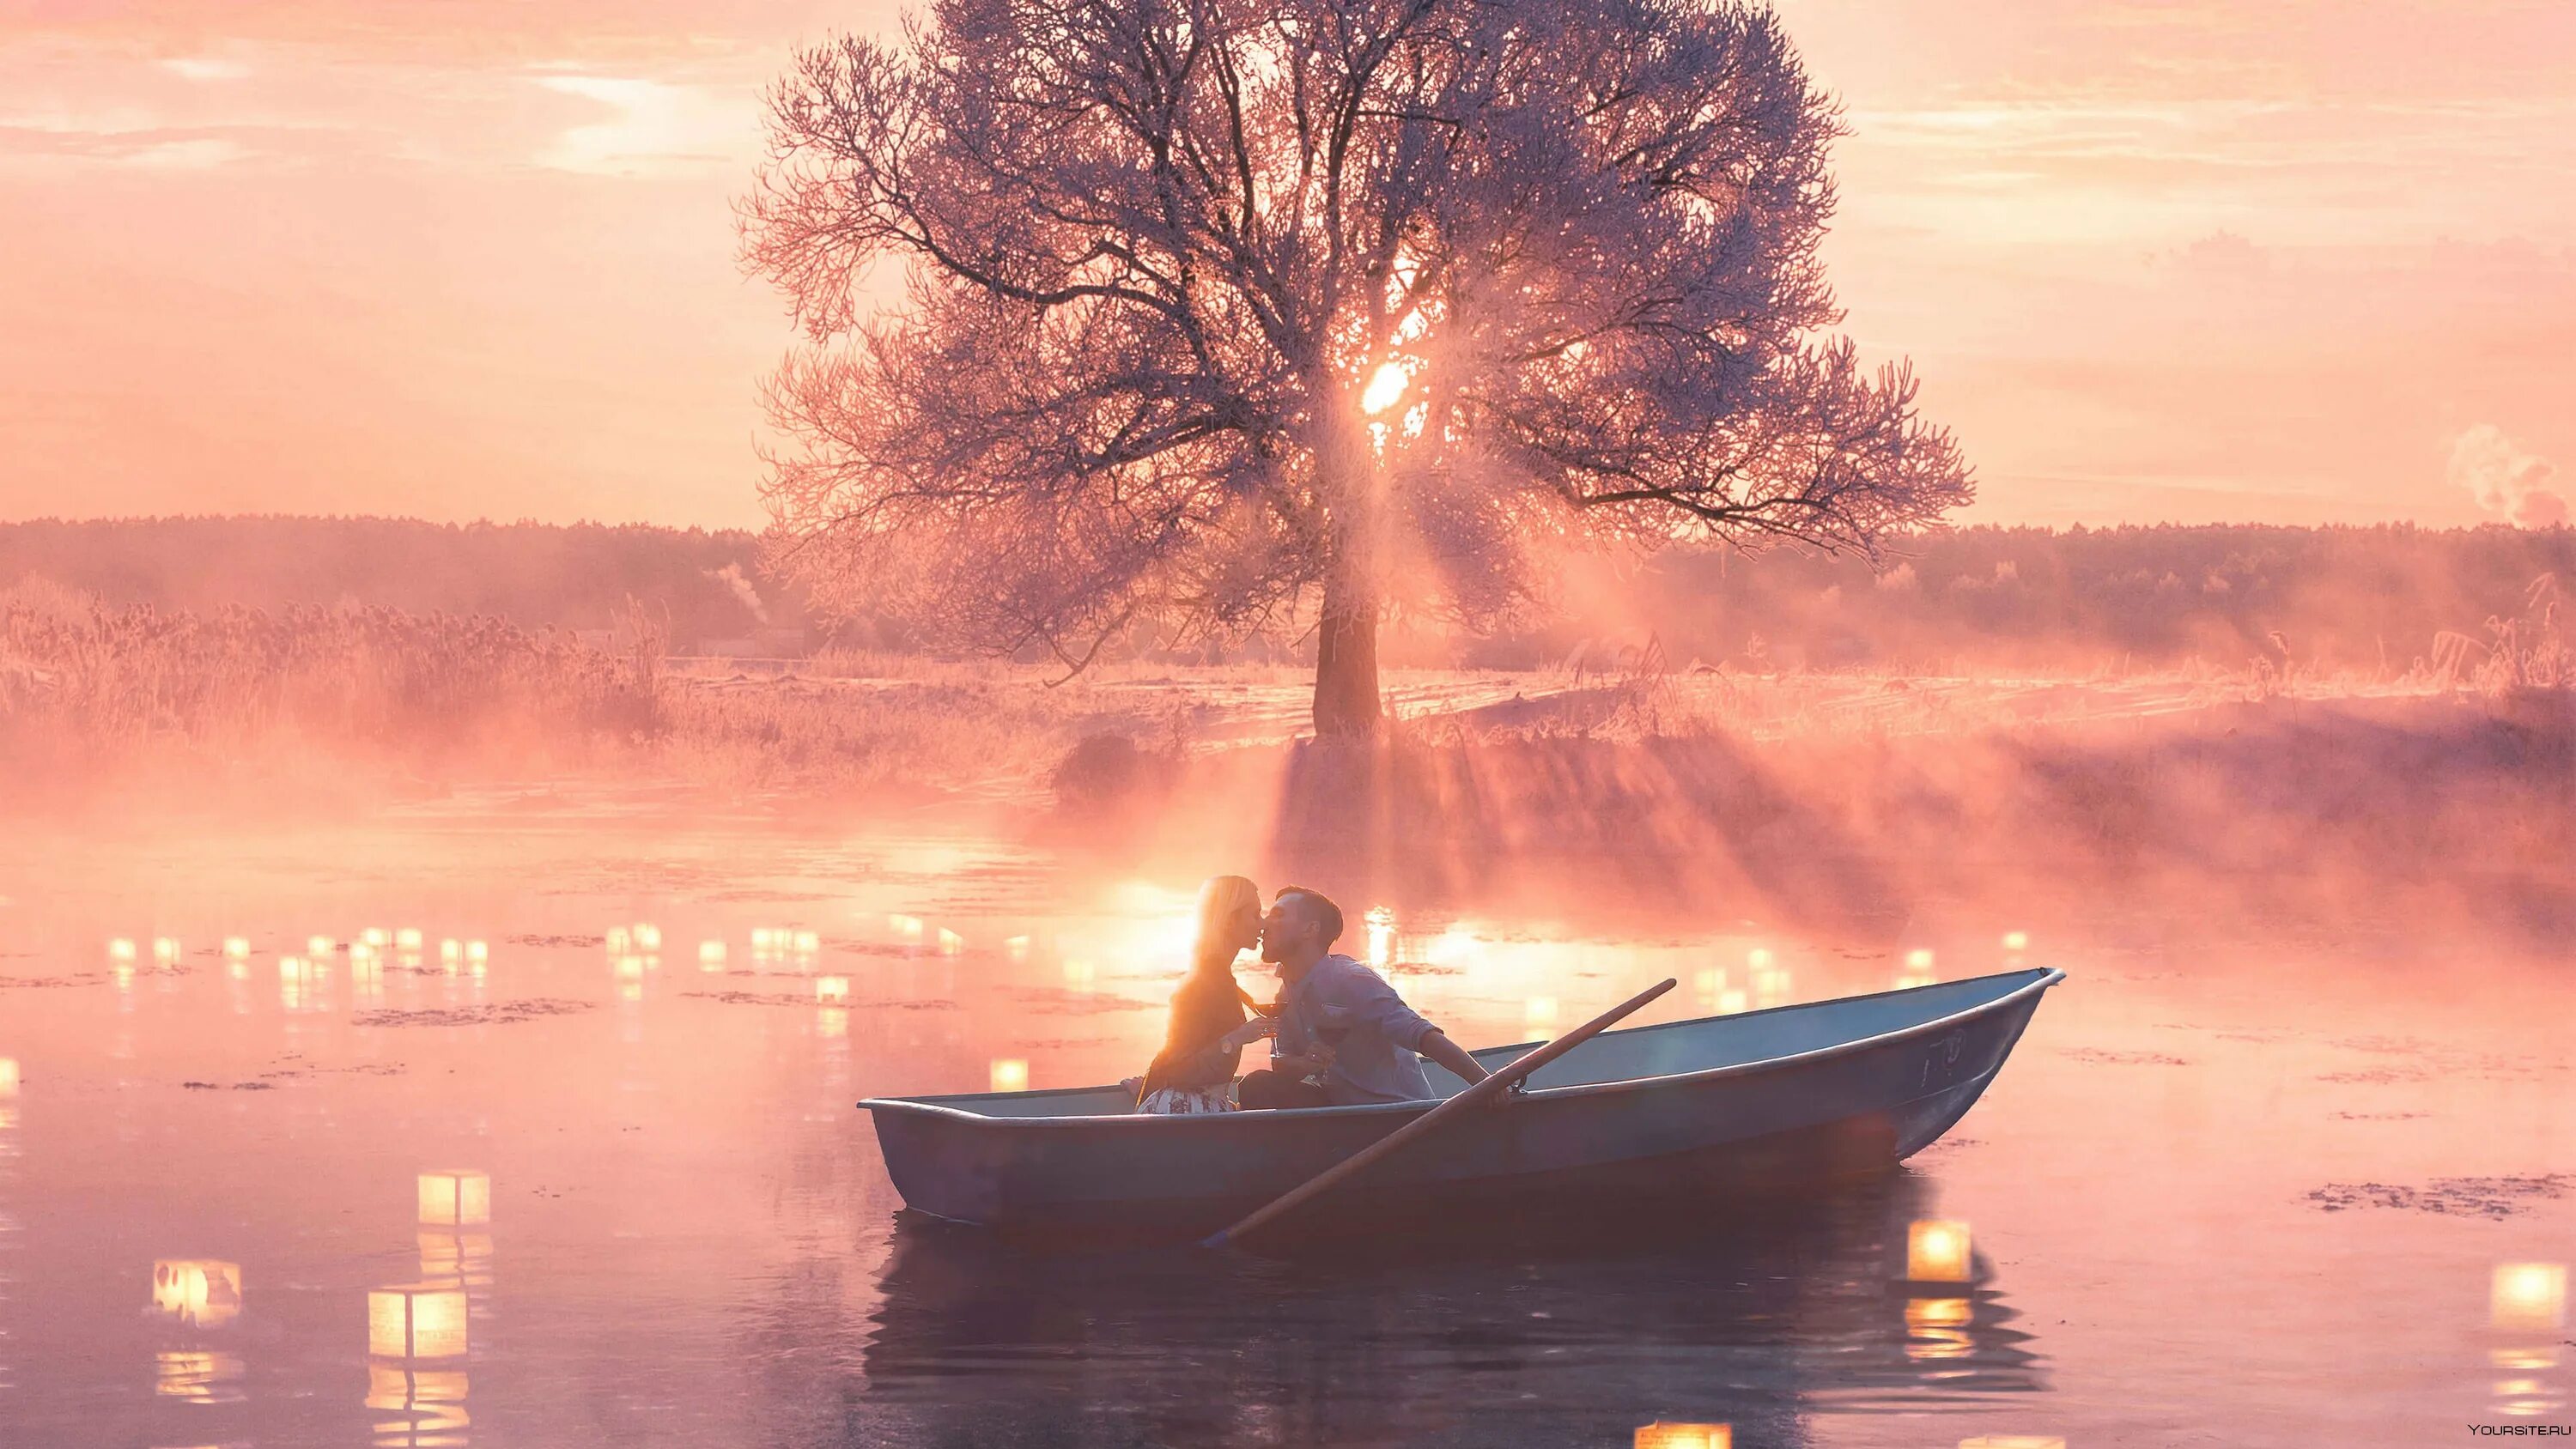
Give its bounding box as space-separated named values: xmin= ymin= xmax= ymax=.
xmin=742 ymin=0 xmax=1971 ymax=733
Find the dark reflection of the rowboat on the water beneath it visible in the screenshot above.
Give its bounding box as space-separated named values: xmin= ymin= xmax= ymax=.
xmin=853 ymin=1173 xmax=2040 ymax=1449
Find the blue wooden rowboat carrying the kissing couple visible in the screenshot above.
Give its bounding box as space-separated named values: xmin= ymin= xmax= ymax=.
xmin=860 ymin=970 xmax=2063 ymax=1233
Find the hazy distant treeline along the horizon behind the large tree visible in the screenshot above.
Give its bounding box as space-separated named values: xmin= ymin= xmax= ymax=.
xmin=0 ymin=518 xmax=2576 ymax=675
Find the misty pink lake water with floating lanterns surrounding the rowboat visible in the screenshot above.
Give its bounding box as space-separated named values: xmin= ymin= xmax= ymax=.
xmin=0 ymin=810 xmax=2576 ymax=1449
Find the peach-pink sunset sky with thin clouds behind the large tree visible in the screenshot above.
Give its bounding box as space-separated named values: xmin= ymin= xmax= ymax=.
xmin=0 ymin=0 xmax=2576 ymax=525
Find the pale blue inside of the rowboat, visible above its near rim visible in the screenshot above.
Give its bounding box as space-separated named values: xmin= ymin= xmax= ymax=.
xmin=889 ymin=967 xmax=2050 ymax=1117
